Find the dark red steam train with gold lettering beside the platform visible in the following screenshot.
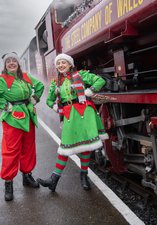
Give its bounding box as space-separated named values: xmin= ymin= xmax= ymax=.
xmin=22 ymin=0 xmax=157 ymax=193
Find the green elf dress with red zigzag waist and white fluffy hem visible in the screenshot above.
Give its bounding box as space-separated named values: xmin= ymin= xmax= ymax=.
xmin=46 ymin=70 xmax=108 ymax=156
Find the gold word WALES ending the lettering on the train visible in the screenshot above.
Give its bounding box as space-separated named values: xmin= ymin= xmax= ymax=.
xmin=117 ymin=0 xmax=144 ymax=18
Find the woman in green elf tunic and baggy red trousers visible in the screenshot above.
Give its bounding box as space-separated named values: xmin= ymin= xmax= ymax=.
xmin=0 ymin=52 xmax=44 ymax=201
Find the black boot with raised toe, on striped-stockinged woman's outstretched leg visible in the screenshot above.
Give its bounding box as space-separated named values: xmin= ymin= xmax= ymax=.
xmin=37 ymin=173 xmax=60 ymax=192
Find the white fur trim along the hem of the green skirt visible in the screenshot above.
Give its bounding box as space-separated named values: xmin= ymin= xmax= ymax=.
xmin=58 ymin=140 xmax=103 ymax=156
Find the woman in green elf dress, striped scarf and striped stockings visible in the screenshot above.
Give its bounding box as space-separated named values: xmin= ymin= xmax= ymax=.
xmin=37 ymin=53 xmax=108 ymax=192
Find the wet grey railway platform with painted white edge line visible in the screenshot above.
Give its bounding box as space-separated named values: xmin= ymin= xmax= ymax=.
xmin=0 ymin=95 xmax=144 ymax=225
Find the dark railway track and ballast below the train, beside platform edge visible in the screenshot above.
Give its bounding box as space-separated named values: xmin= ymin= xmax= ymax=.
xmin=90 ymin=159 xmax=157 ymax=225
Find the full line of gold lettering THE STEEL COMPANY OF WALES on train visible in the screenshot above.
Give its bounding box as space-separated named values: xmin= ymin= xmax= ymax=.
xmin=64 ymin=0 xmax=144 ymax=49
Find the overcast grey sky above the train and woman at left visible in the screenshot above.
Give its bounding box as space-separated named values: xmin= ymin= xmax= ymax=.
xmin=0 ymin=0 xmax=52 ymax=69
